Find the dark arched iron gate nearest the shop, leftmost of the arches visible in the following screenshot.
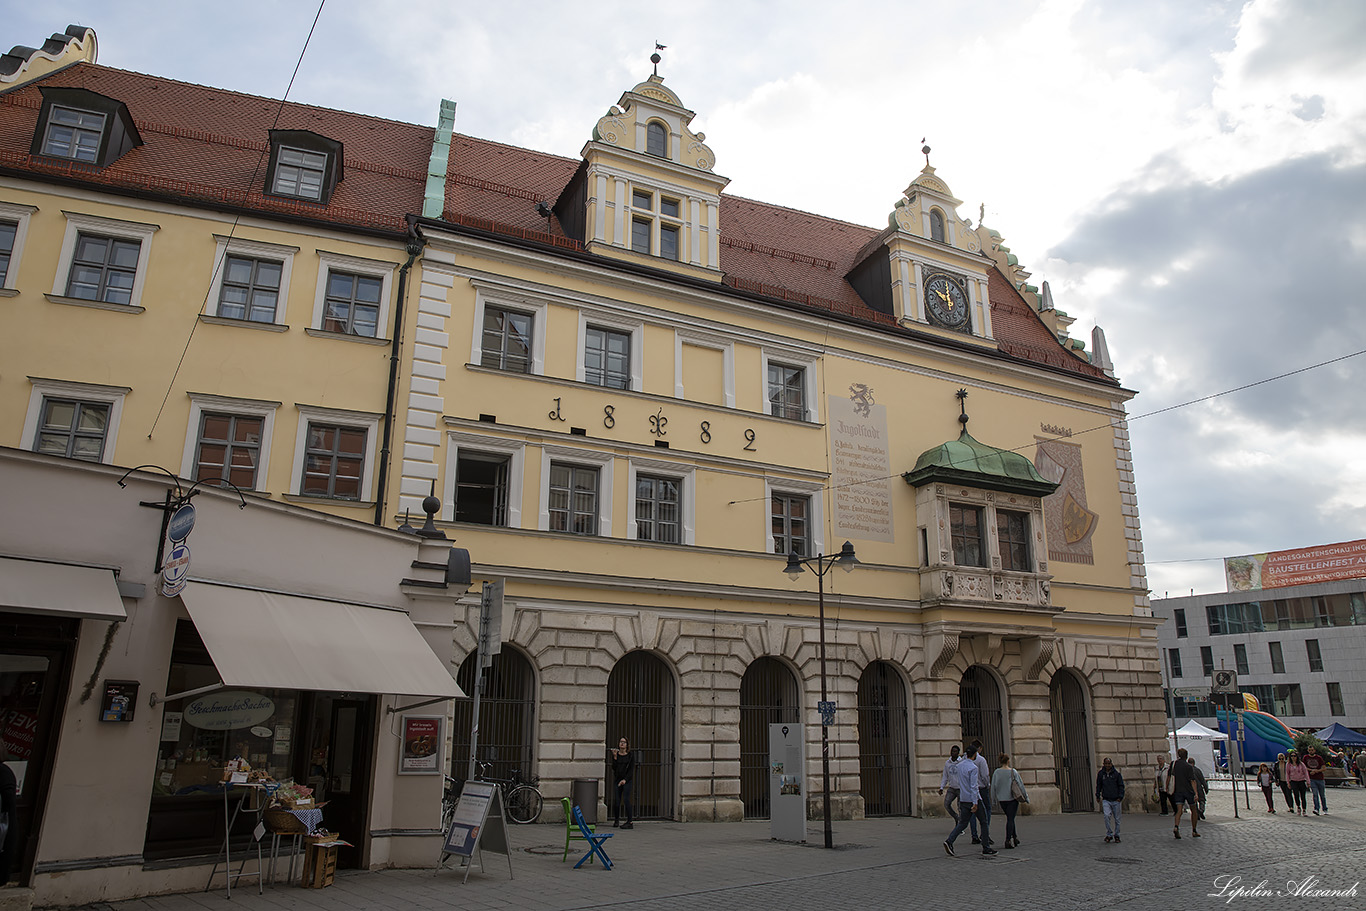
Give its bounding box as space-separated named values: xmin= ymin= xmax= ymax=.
xmin=451 ymin=645 xmax=535 ymax=781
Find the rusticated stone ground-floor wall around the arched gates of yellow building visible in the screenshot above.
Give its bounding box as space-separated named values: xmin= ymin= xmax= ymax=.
xmin=455 ymin=601 xmax=1165 ymax=821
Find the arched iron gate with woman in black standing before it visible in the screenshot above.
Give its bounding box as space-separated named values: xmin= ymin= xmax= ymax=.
xmin=602 ymin=651 xmax=676 ymax=819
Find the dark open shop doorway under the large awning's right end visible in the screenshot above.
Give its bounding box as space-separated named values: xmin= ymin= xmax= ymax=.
xmin=296 ymin=692 xmax=376 ymax=867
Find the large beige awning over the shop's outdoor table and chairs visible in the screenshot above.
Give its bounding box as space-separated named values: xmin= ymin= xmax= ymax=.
xmin=180 ymin=582 xmax=464 ymax=698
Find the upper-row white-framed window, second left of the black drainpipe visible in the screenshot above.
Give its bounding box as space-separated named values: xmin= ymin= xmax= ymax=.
xmin=209 ymin=235 xmax=299 ymax=325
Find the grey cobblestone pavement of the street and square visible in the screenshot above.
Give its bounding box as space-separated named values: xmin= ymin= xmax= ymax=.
xmin=90 ymin=788 xmax=1366 ymax=911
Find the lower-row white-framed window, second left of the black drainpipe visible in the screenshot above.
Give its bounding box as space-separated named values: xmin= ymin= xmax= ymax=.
xmin=180 ymin=393 xmax=280 ymax=490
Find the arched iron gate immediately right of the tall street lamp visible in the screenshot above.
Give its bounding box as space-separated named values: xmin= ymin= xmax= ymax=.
xmin=858 ymin=661 xmax=911 ymax=817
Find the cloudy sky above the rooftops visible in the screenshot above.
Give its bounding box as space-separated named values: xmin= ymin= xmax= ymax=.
xmin=10 ymin=0 xmax=1366 ymax=597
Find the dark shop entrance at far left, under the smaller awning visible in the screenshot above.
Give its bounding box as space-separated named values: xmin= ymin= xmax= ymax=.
xmin=0 ymin=613 xmax=79 ymax=886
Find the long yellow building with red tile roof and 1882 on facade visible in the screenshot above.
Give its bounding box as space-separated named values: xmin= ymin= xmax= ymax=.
xmin=0 ymin=26 xmax=1164 ymax=906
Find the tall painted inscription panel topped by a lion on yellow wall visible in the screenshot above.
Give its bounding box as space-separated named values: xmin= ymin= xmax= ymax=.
xmin=828 ymin=393 xmax=892 ymax=542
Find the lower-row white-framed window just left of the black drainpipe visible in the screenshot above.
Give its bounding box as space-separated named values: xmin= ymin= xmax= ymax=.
xmin=291 ymin=404 xmax=380 ymax=503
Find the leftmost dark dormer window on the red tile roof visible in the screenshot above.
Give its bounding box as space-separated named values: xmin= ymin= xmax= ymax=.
xmin=29 ymin=87 xmax=142 ymax=167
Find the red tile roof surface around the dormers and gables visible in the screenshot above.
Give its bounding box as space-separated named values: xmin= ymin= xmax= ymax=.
xmin=0 ymin=63 xmax=1113 ymax=382
